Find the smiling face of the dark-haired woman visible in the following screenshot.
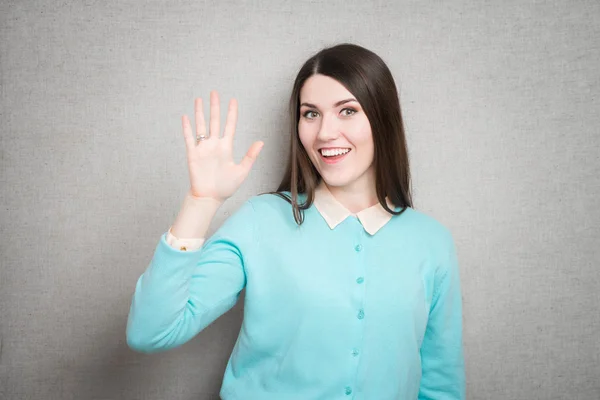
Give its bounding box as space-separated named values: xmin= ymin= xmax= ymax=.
xmin=298 ymin=74 xmax=375 ymax=191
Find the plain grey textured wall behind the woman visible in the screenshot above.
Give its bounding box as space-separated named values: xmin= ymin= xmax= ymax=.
xmin=0 ymin=0 xmax=600 ymax=400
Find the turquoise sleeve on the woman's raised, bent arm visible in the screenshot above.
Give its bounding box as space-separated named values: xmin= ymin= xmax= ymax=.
xmin=126 ymin=200 xmax=257 ymax=353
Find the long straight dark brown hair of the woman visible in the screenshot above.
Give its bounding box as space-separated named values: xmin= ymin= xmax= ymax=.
xmin=262 ymin=43 xmax=413 ymax=225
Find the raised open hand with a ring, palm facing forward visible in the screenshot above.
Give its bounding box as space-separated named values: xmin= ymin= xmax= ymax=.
xmin=182 ymin=91 xmax=264 ymax=202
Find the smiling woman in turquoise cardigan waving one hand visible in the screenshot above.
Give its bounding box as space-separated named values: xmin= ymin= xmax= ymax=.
xmin=127 ymin=44 xmax=465 ymax=400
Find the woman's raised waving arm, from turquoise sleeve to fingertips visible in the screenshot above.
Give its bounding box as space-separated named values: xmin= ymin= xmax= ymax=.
xmin=126 ymin=92 xmax=263 ymax=353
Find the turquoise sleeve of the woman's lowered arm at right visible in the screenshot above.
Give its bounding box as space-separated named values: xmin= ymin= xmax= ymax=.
xmin=418 ymin=236 xmax=465 ymax=400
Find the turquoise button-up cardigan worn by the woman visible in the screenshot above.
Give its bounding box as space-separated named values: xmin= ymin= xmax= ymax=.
xmin=127 ymin=195 xmax=465 ymax=400
